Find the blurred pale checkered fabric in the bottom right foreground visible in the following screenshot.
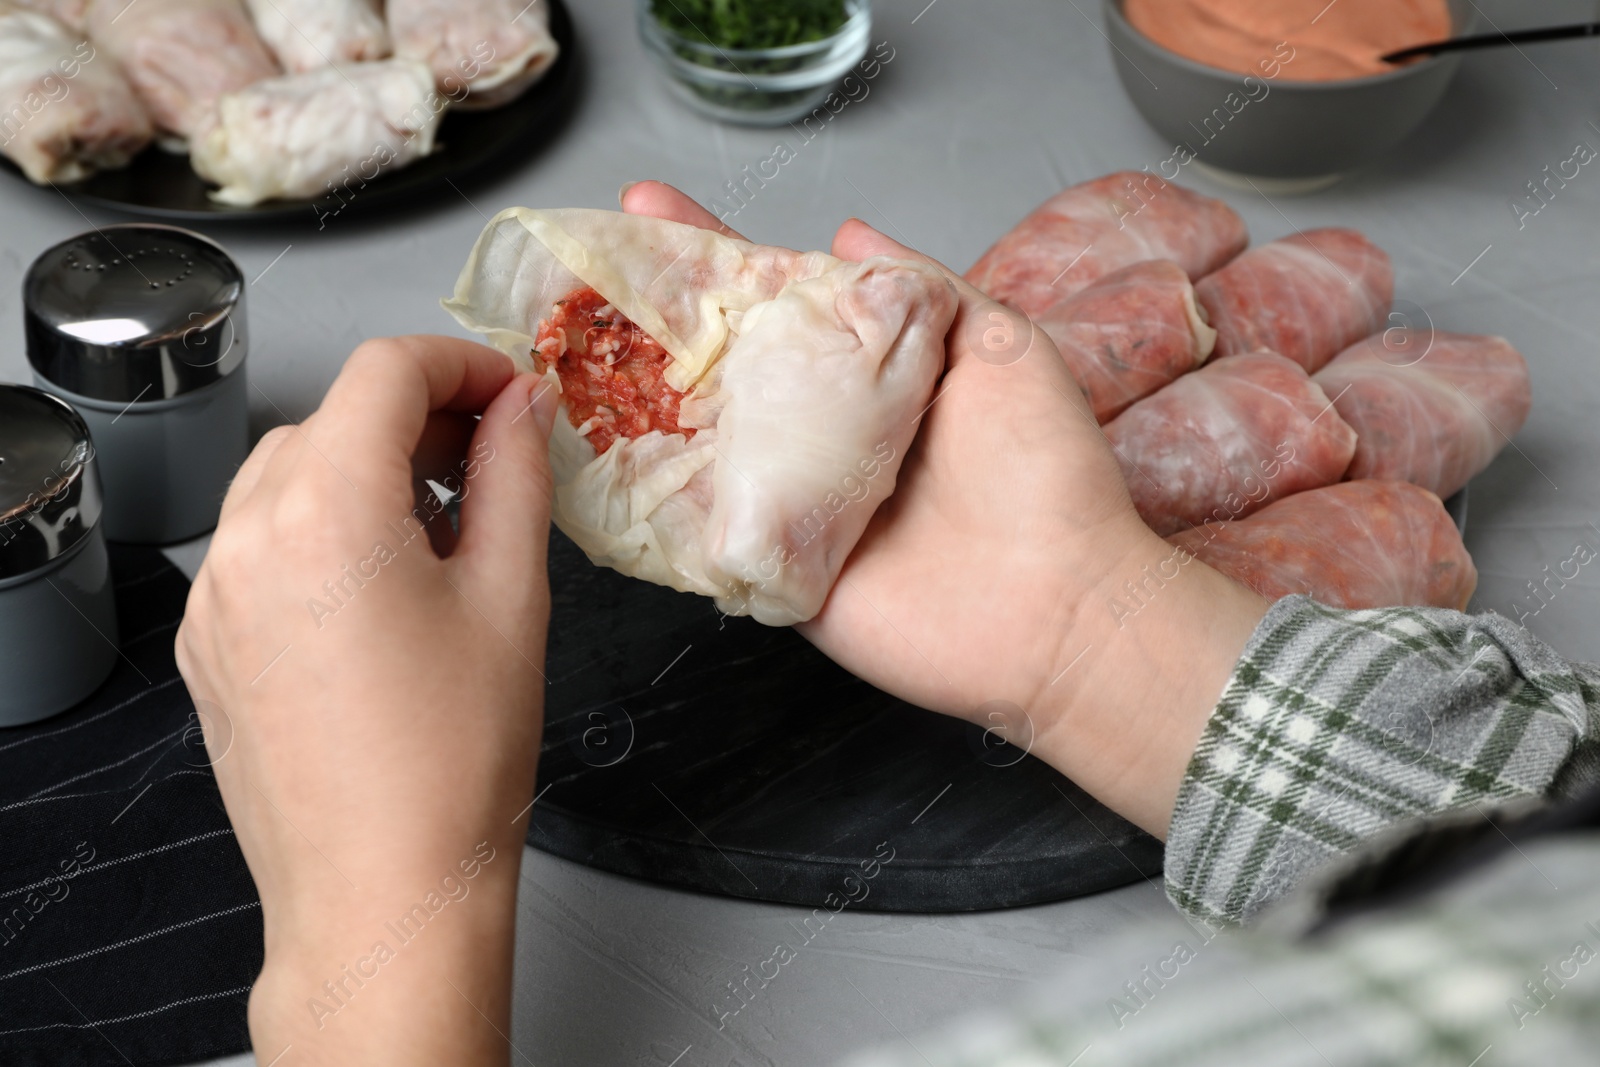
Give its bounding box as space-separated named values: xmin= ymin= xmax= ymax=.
xmin=848 ymin=835 xmax=1600 ymax=1067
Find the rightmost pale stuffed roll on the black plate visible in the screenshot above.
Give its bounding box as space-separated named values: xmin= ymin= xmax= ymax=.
xmin=384 ymin=0 xmax=560 ymax=109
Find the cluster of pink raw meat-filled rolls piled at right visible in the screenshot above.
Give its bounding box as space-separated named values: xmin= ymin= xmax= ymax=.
xmin=966 ymin=173 xmax=1531 ymax=608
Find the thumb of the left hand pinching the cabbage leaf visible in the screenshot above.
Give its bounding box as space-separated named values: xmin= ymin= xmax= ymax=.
xmin=450 ymin=374 xmax=560 ymax=607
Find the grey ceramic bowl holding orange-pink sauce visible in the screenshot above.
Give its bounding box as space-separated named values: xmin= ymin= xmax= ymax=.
xmin=1106 ymin=0 xmax=1477 ymax=184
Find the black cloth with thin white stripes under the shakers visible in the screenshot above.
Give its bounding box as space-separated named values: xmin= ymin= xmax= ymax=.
xmin=0 ymin=545 xmax=262 ymax=1067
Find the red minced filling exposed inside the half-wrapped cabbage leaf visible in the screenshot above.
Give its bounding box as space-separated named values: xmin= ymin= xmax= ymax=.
xmin=533 ymin=288 xmax=694 ymax=454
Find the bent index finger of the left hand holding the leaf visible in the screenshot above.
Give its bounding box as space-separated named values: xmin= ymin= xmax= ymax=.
xmin=310 ymin=336 xmax=514 ymax=496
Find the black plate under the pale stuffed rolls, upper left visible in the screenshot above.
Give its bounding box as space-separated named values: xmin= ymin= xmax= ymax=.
xmin=0 ymin=0 xmax=578 ymax=222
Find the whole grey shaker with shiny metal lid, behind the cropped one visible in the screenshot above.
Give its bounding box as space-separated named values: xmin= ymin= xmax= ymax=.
xmin=22 ymin=224 xmax=250 ymax=544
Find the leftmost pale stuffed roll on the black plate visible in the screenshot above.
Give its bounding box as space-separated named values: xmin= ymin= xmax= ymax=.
xmin=0 ymin=0 xmax=150 ymax=184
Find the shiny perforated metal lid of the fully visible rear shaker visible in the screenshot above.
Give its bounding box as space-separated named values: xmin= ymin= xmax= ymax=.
xmin=22 ymin=222 xmax=245 ymax=403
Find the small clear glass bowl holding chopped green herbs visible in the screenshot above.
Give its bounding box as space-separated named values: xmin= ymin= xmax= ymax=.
xmin=638 ymin=0 xmax=872 ymax=126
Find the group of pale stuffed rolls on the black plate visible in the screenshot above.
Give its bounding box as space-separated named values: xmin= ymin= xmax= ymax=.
xmin=0 ymin=0 xmax=558 ymax=205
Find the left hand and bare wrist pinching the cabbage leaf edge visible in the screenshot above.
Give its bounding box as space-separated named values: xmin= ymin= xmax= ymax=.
xmin=178 ymin=338 xmax=555 ymax=1064
